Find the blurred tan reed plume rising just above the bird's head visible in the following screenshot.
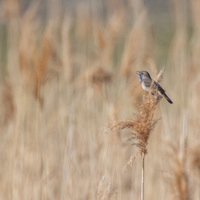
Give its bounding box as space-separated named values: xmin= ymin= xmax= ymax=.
xmin=121 ymin=1 xmax=155 ymax=78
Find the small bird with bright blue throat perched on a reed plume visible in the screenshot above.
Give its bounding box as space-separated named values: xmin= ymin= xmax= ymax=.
xmin=136 ymin=71 xmax=173 ymax=104
